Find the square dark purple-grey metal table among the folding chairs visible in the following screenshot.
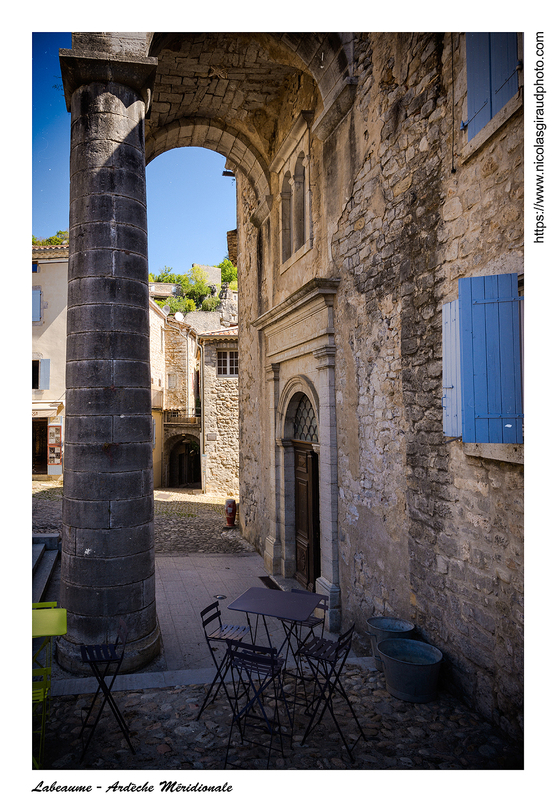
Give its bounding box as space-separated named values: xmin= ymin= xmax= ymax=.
xmin=228 ymin=587 xmax=327 ymax=657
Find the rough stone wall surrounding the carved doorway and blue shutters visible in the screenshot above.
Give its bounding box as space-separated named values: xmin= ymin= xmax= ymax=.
xmin=238 ymin=33 xmax=523 ymax=734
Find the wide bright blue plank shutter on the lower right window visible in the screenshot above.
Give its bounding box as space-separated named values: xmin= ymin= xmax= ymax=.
xmin=459 ymin=273 xmax=523 ymax=443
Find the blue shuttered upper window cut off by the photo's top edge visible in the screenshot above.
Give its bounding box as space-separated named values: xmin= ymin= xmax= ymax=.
xmin=464 ymin=33 xmax=519 ymax=140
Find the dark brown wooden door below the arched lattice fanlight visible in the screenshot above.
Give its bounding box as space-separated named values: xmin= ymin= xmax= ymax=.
xmin=294 ymin=443 xmax=320 ymax=591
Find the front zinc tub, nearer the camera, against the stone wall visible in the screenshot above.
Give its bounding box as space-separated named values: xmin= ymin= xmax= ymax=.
xmin=378 ymin=638 xmax=442 ymax=703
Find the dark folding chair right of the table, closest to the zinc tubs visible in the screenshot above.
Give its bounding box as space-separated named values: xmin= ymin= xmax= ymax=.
xmin=298 ymin=624 xmax=367 ymax=761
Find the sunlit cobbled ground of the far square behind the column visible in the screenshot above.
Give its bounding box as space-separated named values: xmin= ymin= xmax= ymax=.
xmin=32 ymin=481 xmax=254 ymax=554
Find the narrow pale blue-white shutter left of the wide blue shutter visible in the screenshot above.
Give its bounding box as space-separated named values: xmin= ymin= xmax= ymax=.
xmin=442 ymin=301 xmax=461 ymax=437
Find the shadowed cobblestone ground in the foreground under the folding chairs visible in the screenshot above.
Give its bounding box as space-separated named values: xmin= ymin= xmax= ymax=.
xmin=38 ymin=666 xmax=523 ymax=770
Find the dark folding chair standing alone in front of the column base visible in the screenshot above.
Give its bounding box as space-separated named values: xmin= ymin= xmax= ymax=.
xmin=80 ymin=619 xmax=135 ymax=760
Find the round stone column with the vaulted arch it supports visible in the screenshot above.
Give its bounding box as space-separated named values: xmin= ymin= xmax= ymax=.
xmin=58 ymin=32 xmax=354 ymax=670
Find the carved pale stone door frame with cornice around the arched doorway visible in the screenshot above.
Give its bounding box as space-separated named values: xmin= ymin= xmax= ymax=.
xmin=253 ymin=279 xmax=341 ymax=632
